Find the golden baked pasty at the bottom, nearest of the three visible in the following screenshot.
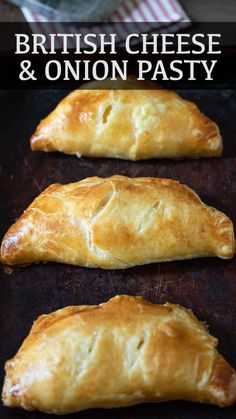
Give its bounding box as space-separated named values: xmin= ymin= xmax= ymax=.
xmin=3 ymin=295 xmax=236 ymax=414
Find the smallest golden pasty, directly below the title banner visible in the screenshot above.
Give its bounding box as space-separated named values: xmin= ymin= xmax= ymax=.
xmin=31 ymin=80 xmax=222 ymax=160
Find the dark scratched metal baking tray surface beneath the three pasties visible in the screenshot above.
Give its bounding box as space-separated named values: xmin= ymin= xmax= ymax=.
xmin=0 ymin=91 xmax=236 ymax=419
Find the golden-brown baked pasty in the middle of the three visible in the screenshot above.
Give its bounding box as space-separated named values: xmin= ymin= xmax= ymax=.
xmin=1 ymin=176 xmax=234 ymax=269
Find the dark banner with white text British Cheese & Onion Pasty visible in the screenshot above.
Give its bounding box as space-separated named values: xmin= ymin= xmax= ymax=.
xmin=0 ymin=22 xmax=236 ymax=89
